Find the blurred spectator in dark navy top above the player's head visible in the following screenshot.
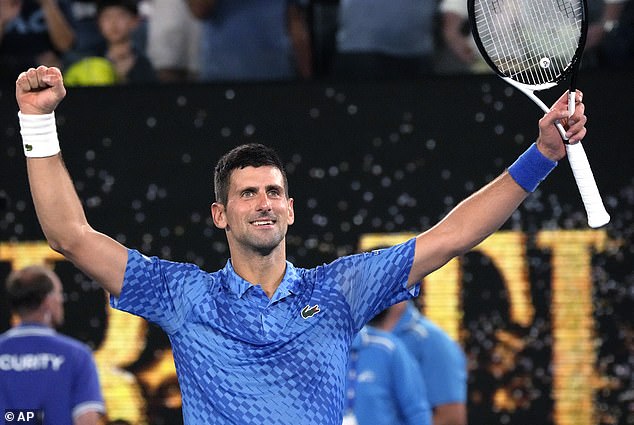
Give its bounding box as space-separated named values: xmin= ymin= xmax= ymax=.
xmin=188 ymin=0 xmax=312 ymax=81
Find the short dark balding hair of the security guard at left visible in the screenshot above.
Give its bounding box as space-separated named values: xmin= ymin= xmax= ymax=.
xmin=6 ymin=266 xmax=55 ymax=314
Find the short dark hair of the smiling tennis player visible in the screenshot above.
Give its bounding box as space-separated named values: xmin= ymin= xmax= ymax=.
xmin=214 ymin=143 xmax=289 ymax=205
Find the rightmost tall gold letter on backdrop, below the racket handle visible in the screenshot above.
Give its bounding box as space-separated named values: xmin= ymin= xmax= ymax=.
xmin=537 ymin=230 xmax=607 ymax=425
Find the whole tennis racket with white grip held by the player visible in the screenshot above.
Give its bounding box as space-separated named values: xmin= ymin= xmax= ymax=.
xmin=467 ymin=0 xmax=610 ymax=228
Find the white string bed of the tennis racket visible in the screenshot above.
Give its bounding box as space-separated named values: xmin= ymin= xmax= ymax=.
xmin=474 ymin=0 xmax=583 ymax=85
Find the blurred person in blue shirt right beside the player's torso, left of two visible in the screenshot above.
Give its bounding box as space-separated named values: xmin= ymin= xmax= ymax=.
xmin=343 ymin=310 xmax=432 ymax=425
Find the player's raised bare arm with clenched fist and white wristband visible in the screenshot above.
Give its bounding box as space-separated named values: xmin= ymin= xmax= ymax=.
xmin=16 ymin=66 xmax=128 ymax=296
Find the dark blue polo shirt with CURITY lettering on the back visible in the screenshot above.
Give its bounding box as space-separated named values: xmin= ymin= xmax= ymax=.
xmin=0 ymin=324 xmax=105 ymax=425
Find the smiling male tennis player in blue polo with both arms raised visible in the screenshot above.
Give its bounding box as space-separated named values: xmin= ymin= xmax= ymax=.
xmin=16 ymin=66 xmax=586 ymax=425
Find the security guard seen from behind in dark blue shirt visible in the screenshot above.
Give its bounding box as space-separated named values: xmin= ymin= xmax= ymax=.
xmin=0 ymin=266 xmax=104 ymax=425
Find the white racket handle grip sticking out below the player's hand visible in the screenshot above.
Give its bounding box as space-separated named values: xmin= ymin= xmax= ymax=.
xmin=566 ymin=142 xmax=610 ymax=229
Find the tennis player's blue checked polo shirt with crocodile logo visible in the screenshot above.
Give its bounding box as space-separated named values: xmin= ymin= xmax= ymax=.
xmin=111 ymin=239 xmax=419 ymax=425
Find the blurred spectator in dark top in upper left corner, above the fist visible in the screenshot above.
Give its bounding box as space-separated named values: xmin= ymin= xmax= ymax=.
xmin=0 ymin=0 xmax=75 ymax=82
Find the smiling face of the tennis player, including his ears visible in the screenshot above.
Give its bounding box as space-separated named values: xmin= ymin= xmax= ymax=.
xmin=211 ymin=165 xmax=295 ymax=256
